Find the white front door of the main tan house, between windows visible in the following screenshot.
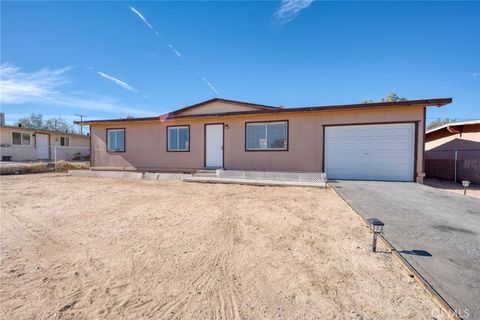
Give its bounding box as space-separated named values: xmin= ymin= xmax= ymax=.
xmin=205 ymin=124 xmax=223 ymax=167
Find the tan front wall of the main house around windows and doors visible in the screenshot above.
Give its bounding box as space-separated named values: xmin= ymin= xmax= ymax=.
xmin=91 ymin=107 xmax=424 ymax=179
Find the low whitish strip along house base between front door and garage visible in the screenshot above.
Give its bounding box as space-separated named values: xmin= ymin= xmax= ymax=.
xmin=217 ymin=169 xmax=327 ymax=182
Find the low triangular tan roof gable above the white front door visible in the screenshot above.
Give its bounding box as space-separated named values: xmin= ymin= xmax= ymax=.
xmin=170 ymin=98 xmax=277 ymax=116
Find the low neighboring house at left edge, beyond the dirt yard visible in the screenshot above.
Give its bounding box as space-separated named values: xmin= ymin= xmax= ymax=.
xmin=0 ymin=125 xmax=90 ymax=161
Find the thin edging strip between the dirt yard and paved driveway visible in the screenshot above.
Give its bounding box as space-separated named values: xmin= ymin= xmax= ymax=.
xmin=329 ymin=187 xmax=462 ymax=320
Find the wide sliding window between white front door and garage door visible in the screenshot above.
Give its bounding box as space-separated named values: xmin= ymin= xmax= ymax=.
xmin=245 ymin=121 xmax=288 ymax=151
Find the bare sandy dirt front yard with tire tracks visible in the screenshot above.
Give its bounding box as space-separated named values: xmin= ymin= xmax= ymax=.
xmin=0 ymin=173 xmax=438 ymax=319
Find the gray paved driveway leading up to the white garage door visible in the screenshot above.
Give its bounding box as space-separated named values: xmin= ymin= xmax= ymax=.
xmin=332 ymin=181 xmax=480 ymax=319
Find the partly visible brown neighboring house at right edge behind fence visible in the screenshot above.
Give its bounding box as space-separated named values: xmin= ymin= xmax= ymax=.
xmin=425 ymin=120 xmax=480 ymax=184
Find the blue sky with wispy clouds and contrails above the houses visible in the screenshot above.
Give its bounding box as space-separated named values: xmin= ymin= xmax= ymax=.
xmin=1 ymin=0 xmax=480 ymax=131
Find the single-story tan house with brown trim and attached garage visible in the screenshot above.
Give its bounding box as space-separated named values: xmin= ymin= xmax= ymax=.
xmin=77 ymin=98 xmax=452 ymax=182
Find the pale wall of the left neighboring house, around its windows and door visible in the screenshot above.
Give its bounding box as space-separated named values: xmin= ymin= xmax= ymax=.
xmin=0 ymin=127 xmax=90 ymax=161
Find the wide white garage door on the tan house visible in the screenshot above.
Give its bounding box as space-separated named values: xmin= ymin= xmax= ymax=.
xmin=325 ymin=123 xmax=415 ymax=181
